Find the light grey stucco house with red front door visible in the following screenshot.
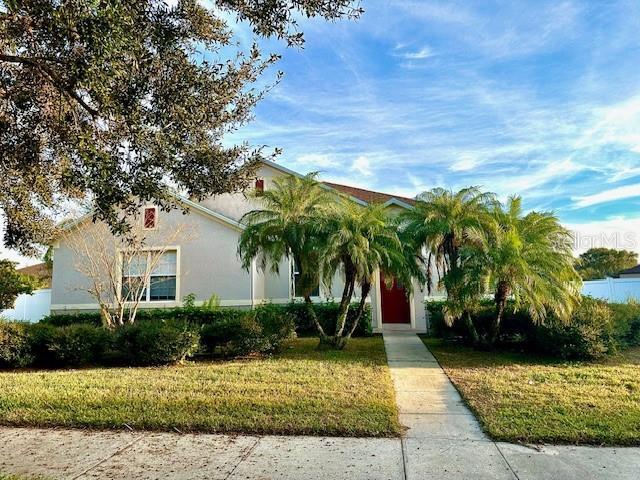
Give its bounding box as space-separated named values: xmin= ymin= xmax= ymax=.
xmin=51 ymin=161 xmax=427 ymax=332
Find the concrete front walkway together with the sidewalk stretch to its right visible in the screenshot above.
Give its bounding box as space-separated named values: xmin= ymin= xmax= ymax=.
xmin=384 ymin=332 xmax=640 ymax=480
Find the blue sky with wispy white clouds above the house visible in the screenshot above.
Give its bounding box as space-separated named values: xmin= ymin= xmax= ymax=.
xmin=0 ymin=0 xmax=640 ymax=264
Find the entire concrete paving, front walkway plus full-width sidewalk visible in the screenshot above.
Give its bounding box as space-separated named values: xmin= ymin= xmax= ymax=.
xmin=0 ymin=332 xmax=640 ymax=480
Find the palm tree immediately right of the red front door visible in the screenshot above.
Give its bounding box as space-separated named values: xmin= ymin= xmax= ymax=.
xmin=401 ymin=187 xmax=497 ymax=339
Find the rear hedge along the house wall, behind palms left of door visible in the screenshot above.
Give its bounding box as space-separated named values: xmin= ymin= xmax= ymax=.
xmin=41 ymin=302 xmax=372 ymax=336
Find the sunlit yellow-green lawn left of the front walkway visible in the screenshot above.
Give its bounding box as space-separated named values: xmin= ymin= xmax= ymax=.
xmin=0 ymin=337 xmax=400 ymax=436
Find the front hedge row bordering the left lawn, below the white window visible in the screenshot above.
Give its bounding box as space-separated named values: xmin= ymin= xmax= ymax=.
xmin=0 ymin=306 xmax=294 ymax=368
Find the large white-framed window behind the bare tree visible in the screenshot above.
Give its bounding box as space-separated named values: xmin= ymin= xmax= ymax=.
xmin=122 ymin=250 xmax=178 ymax=302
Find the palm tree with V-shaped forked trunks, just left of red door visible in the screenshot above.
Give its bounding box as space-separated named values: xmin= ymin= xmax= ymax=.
xmin=321 ymin=201 xmax=410 ymax=348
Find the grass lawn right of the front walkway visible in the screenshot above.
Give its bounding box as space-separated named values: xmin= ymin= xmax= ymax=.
xmin=423 ymin=339 xmax=640 ymax=445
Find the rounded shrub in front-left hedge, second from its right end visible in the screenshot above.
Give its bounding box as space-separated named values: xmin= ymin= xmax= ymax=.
xmin=112 ymin=320 xmax=200 ymax=365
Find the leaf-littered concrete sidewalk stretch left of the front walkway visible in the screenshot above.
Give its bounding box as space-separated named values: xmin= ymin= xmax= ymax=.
xmin=0 ymin=428 xmax=403 ymax=480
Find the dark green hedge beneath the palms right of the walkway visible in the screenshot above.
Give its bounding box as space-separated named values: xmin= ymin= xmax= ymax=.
xmin=426 ymin=297 xmax=640 ymax=359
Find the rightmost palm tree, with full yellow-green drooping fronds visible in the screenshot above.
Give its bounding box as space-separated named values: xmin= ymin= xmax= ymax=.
xmin=482 ymin=197 xmax=582 ymax=344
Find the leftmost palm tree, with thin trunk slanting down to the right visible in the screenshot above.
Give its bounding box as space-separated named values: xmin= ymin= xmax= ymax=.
xmin=238 ymin=173 xmax=336 ymax=341
